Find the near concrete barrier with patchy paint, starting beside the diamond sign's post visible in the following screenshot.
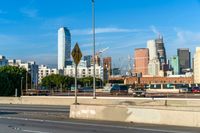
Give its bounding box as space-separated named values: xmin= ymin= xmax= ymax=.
xmin=70 ymin=105 xmax=200 ymax=127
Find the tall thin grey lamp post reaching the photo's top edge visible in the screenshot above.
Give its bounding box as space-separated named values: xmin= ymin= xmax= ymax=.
xmin=92 ymin=0 xmax=96 ymax=99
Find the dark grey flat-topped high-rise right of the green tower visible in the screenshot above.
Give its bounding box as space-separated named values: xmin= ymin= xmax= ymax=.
xmin=177 ymin=48 xmax=191 ymax=74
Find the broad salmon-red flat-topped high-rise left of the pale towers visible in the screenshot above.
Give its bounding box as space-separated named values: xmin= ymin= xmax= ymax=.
xmin=133 ymin=48 xmax=149 ymax=75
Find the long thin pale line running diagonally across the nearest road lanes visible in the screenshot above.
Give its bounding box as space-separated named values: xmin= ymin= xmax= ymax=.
xmin=0 ymin=116 xmax=191 ymax=133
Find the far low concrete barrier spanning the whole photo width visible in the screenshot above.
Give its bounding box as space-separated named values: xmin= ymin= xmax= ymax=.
xmin=0 ymin=96 xmax=200 ymax=107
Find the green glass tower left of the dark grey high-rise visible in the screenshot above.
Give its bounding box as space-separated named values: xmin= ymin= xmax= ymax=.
xmin=170 ymin=56 xmax=179 ymax=75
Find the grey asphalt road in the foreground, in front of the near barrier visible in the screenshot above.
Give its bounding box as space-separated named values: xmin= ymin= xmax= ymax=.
xmin=0 ymin=105 xmax=200 ymax=133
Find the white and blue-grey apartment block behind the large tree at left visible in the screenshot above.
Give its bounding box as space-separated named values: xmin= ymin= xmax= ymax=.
xmin=8 ymin=59 xmax=38 ymax=88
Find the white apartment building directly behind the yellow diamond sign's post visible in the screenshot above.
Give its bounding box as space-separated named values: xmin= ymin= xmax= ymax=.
xmin=64 ymin=60 xmax=103 ymax=79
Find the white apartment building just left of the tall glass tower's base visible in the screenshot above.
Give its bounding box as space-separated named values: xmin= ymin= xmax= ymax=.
xmin=38 ymin=65 xmax=58 ymax=83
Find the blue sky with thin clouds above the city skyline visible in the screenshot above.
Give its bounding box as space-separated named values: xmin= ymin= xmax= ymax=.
xmin=0 ymin=0 xmax=200 ymax=67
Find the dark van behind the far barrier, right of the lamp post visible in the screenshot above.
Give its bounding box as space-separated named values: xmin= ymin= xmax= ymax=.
xmin=110 ymin=84 xmax=128 ymax=95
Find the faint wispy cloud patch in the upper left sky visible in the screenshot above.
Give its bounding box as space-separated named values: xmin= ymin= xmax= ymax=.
xmin=20 ymin=8 xmax=38 ymax=18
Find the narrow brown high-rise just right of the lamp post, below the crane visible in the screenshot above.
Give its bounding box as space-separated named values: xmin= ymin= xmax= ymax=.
xmin=103 ymin=57 xmax=112 ymax=80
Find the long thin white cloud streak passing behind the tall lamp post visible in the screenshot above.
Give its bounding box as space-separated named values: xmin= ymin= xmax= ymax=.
xmin=71 ymin=27 xmax=142 ymax=35
